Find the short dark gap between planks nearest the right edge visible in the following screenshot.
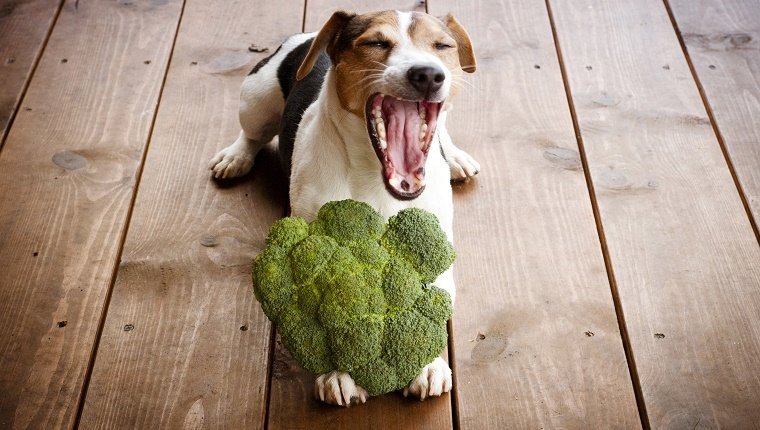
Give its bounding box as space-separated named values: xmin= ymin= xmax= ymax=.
xmin=662 ymin=0 xmax=760 ymax=249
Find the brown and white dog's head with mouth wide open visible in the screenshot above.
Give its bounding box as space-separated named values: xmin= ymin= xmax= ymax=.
xmin=297 ymin=11 xmax=475 ymax=199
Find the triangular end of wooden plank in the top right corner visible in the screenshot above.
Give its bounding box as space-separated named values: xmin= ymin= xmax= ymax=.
xmin=670 ymin=0 xmax=760 ymax=240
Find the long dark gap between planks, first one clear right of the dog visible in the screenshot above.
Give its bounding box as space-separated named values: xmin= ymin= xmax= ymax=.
xmin=544 ymin=0 xmax=652 ymax=430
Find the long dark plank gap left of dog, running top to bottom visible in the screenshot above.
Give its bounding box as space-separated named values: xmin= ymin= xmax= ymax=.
xmin=70 ymin=0 xmax=186 ymax=429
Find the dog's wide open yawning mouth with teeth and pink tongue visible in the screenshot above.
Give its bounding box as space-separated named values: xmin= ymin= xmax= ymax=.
xmin=365 ymin=94 xmax=441 ymax=200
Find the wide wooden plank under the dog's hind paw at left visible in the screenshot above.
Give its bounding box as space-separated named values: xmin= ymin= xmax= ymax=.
xmin=81 ymin=0 xmax=303 ymax=428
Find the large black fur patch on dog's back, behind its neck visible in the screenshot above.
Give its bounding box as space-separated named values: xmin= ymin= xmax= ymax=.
xmin=277 ymin=38 xmax=330 ymax=179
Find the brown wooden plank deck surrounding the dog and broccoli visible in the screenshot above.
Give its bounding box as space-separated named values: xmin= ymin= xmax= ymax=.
xmin=0 ymin=0 xmax=760 ymax=429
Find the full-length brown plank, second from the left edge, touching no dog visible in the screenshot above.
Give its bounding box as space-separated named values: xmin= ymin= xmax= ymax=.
xmin=0 ymin=1 xmax=181 ymax=428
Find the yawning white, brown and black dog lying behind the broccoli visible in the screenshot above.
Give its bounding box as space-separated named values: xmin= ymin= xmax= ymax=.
xmin=210 ymin=11 xmax=480 ymax=406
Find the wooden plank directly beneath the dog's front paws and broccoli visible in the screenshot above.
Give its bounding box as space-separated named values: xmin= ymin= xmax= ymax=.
xmin=268 ymin=0 xmax=452 ymax=429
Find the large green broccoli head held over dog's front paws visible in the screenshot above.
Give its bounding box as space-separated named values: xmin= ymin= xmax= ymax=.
xmin=252 ymin=200 xmax=454 ymax=396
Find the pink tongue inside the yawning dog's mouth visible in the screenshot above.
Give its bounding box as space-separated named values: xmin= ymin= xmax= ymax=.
xmin=382 ymin=97 xmax=426 ymax=186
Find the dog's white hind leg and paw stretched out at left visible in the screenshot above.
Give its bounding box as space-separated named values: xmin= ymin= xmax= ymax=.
xmin=209 ymin=53 xmax=285 ymax=178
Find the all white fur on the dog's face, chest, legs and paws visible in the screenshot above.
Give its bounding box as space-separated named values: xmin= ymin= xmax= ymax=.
xmin=210 ymin=17 xmax=480 ymax=406
